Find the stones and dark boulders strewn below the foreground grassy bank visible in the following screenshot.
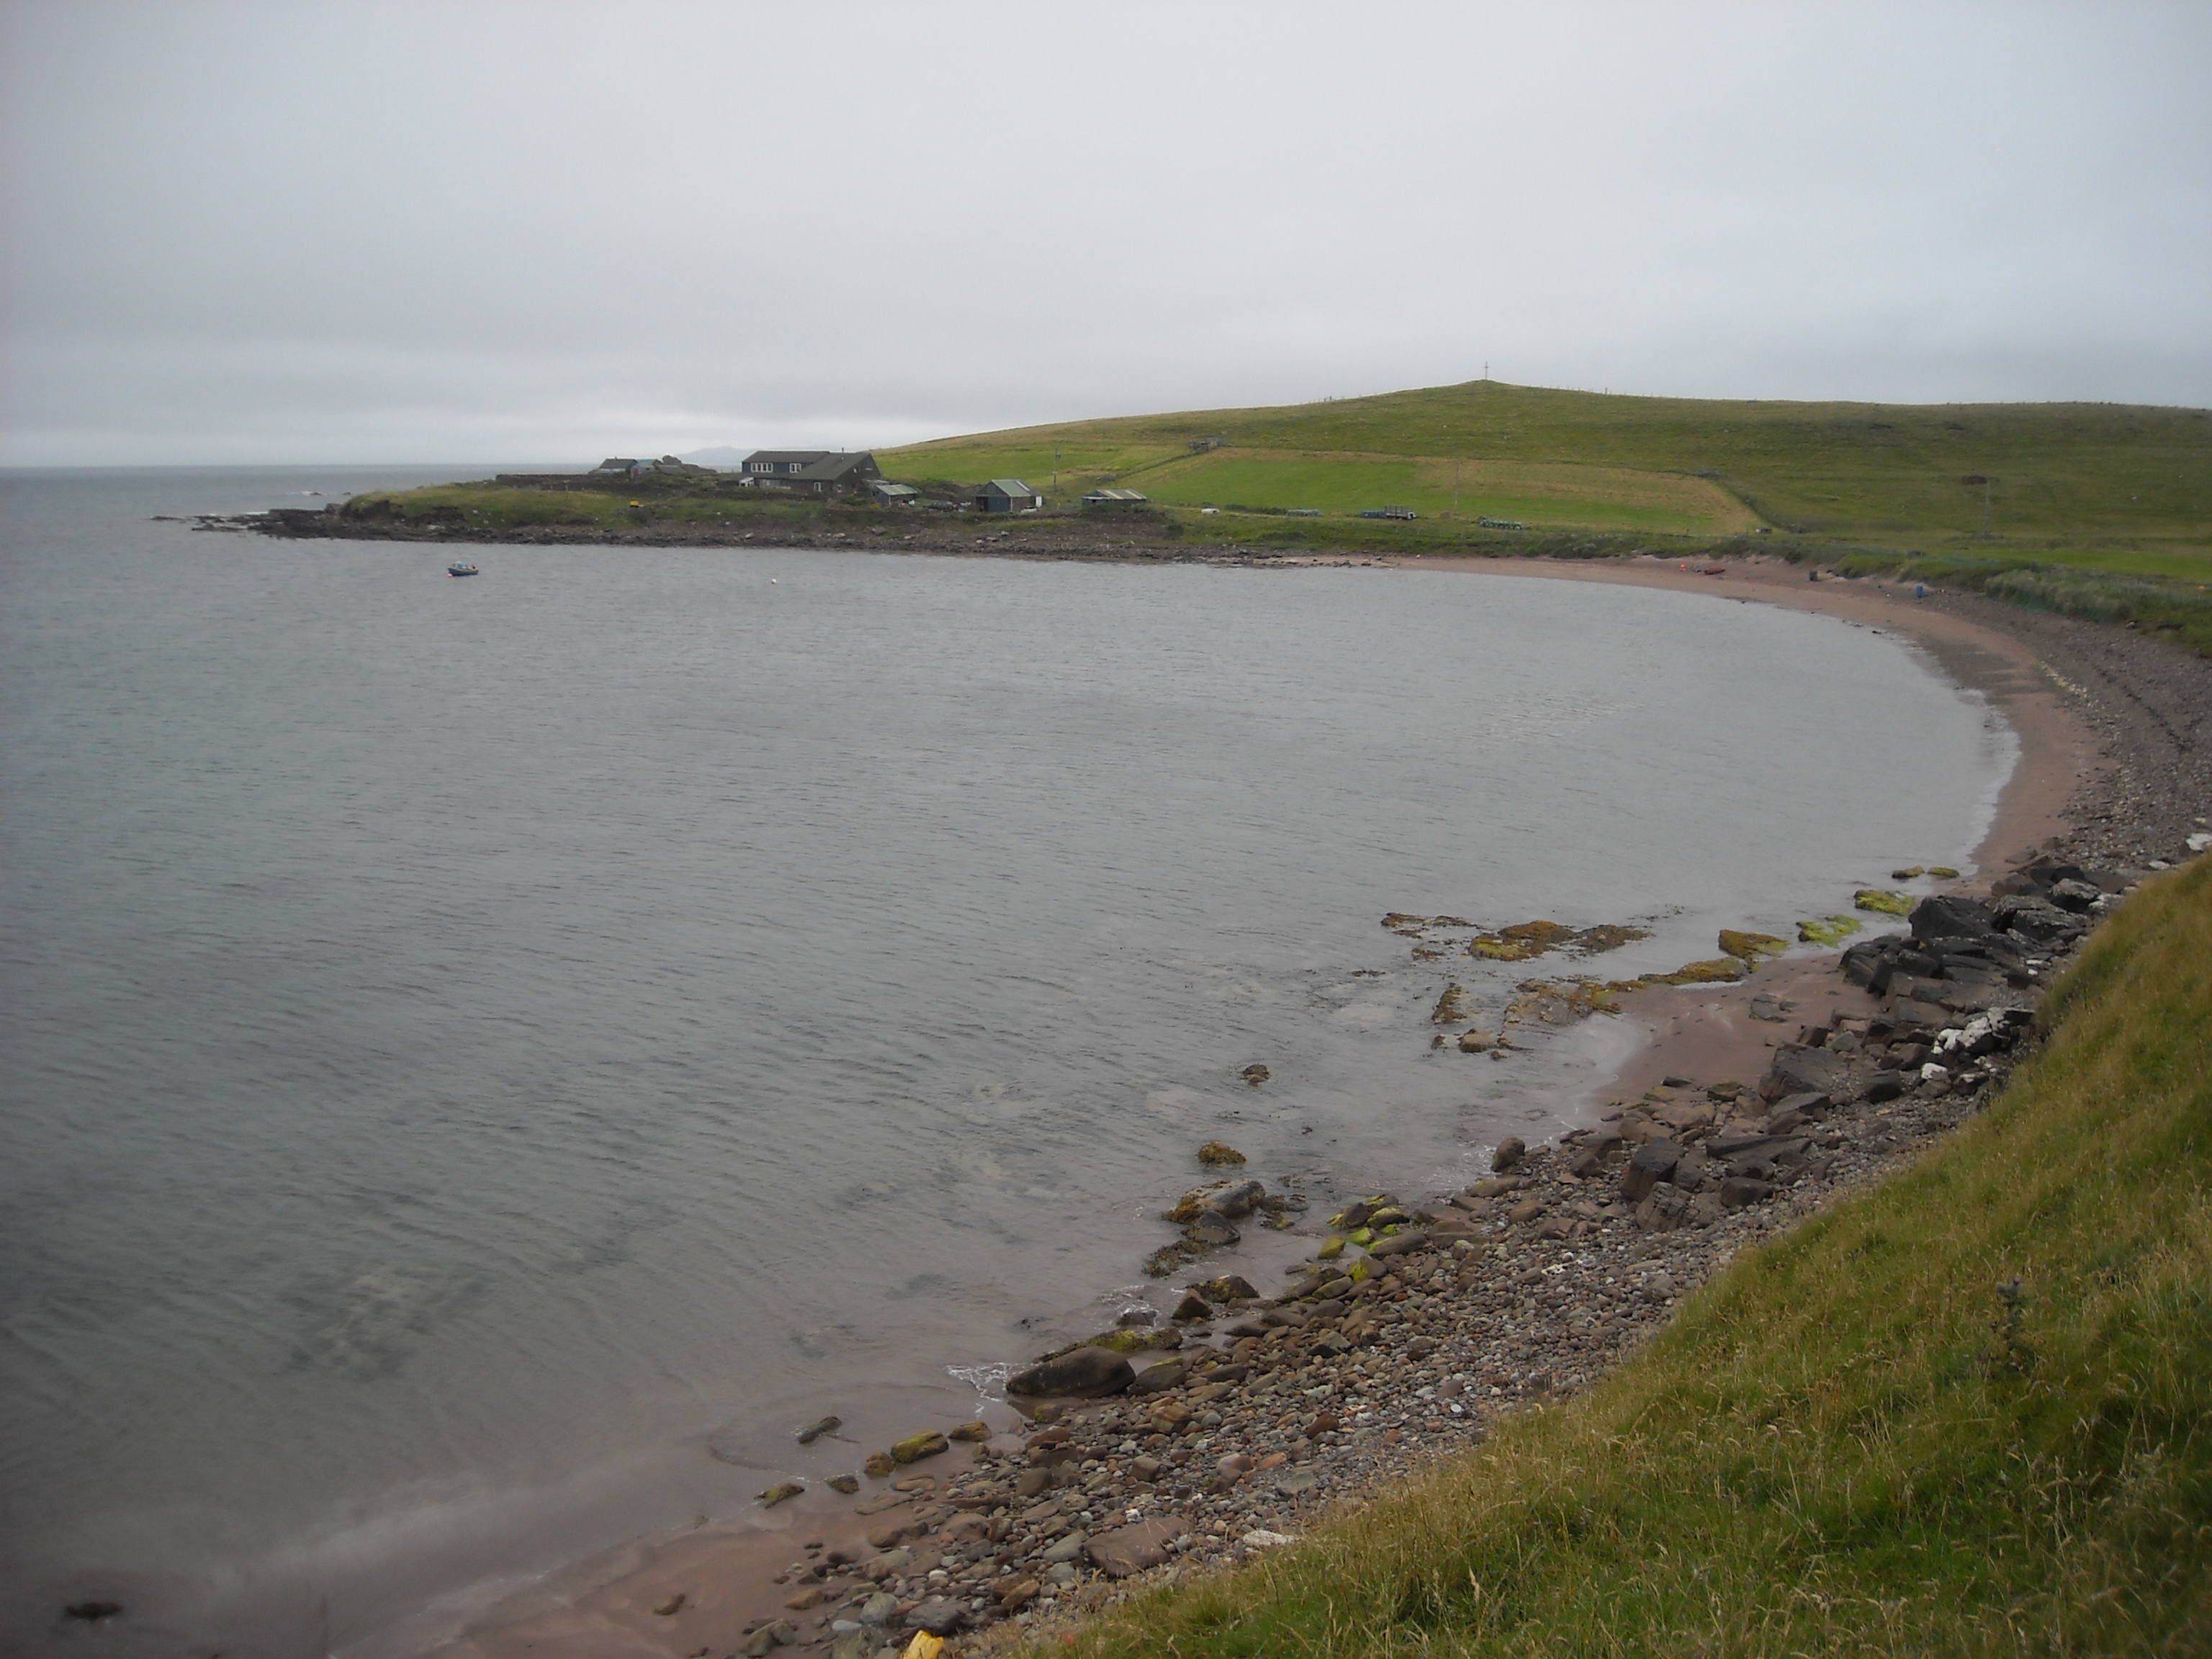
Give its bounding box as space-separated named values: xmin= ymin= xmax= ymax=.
xmin=677 ymin=860 xmax=2130 ymax=1659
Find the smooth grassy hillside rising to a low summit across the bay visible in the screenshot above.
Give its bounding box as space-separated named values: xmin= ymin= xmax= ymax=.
xmin=881 ymin=380 xmax=2212 ymax=559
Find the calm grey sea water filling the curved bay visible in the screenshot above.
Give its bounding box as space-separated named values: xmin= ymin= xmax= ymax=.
xmin=0 ymin=471 xmax=2013 ymax=1655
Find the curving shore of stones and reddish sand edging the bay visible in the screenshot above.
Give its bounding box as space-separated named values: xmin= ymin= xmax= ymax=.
xmin=380 ymin=549 xmax=2212 ymax=1659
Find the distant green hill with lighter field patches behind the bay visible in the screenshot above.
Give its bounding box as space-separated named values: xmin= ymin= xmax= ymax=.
xmin=878 ymin=380 xmax=2212 ymax=575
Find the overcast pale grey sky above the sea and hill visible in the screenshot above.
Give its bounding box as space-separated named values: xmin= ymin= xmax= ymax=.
xmin=0 ymin=0 xmax=2212 ymax=464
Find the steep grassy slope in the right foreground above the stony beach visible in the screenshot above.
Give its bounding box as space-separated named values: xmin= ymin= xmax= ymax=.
xmin=1077 ymin=858 xmax=2212 ymax=1659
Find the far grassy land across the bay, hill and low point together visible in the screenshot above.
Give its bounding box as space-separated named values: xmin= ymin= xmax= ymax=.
xmin=228 ymin=380 xmax=2212 ymax=655
